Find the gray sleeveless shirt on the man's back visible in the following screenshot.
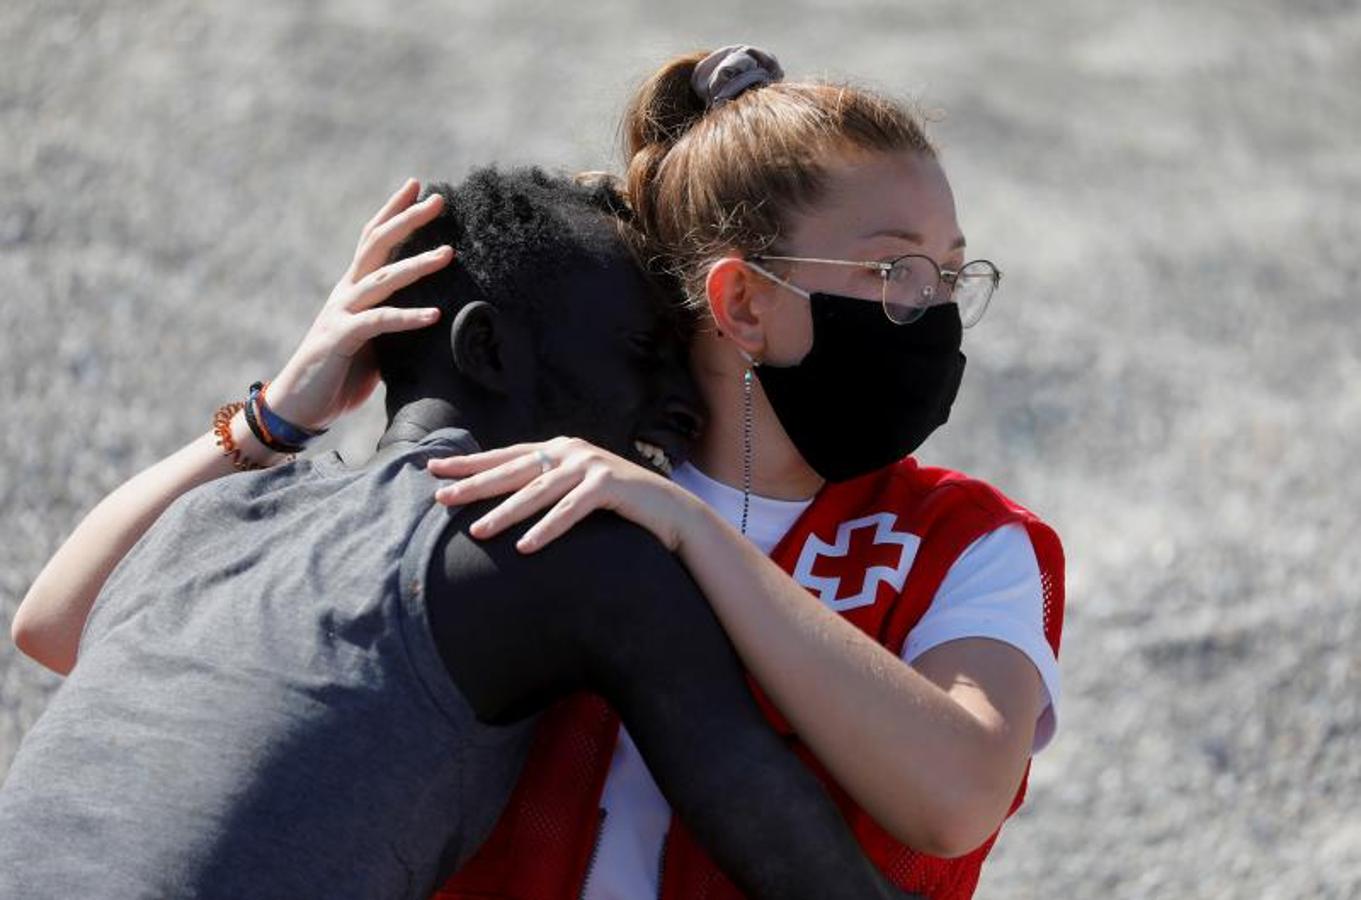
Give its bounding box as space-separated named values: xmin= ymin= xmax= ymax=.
xmin=0 ymin=429 xmax=529 ymax=900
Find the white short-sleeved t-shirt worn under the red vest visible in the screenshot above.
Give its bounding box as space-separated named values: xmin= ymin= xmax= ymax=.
xmin=583 ymin=463 xmax=1059 ymax=900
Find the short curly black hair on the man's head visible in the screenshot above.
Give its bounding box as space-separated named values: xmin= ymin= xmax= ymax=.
xmin=374 ymin=167 xmax=656 ymax=392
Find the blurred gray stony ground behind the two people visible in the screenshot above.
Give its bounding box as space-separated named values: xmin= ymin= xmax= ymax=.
xmin=0 ymin=0 xmax=1361 ymax=897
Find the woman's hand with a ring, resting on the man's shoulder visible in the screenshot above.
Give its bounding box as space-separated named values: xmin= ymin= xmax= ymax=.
xmin=429 ymin=437 xmax=700 ymax=553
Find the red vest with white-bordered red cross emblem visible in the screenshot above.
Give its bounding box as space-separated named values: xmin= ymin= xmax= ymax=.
xmin=434 ymin=459 xmax=1063 ymax=900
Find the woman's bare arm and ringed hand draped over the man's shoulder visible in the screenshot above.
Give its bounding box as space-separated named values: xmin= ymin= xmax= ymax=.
xmin=430 ymin=438 xmax=1045 ymax=856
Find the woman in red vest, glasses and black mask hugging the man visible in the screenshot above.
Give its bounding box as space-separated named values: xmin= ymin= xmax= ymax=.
xmin=15 ymin=46 xmax=1063 ymax=897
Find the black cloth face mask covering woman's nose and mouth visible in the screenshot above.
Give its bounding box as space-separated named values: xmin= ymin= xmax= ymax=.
xmin=755 ymin=294 xmax=965 ymax=482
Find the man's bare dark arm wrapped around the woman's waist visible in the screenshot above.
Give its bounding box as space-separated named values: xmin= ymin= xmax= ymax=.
xmin=429 ymin=512 xmax=901 ymax=900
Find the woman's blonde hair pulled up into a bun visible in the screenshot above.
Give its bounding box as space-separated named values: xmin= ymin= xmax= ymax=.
xmin=622 ymin=52 xmax=935 ymax=306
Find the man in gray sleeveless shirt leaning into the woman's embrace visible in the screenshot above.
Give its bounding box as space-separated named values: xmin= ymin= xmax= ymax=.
xmin=0 ymin=172 xmax=920 ymax=900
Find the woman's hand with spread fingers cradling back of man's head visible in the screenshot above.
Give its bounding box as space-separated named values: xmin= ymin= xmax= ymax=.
xmin=262 ymin=178 xmax=453 ymax=429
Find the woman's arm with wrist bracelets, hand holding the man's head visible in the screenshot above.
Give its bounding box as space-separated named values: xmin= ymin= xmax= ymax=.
xmin=11 ymin=181 xmax=453 ymax=674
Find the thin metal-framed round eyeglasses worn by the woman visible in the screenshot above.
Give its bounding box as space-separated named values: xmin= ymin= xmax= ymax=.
xmin=747 ymin=253 xmax=1002 ymax=328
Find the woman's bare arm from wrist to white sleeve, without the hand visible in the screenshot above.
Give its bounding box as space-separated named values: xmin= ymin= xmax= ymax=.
xmin=679 ymin=501 xmax=1045 ymax=856
